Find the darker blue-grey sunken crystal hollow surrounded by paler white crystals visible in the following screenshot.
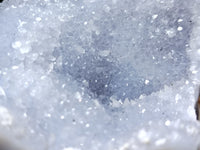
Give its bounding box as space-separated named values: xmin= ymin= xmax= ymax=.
xmin=60 ymin=1 xmax=192 ymax=101
